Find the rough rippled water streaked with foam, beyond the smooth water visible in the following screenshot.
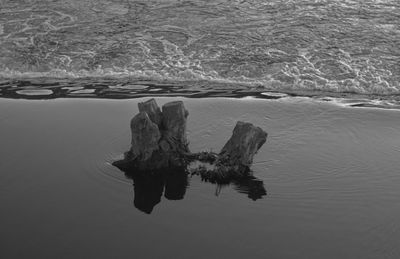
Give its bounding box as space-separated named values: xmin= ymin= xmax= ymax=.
xmin=0 ymin=0 xmax=400 ymax=99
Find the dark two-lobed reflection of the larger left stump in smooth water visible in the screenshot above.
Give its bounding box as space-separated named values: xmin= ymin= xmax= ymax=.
xmin=125 ymin=170 xmax=188 ymax=214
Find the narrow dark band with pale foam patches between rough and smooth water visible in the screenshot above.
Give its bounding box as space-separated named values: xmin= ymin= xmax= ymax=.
xmin=0 ymin=77 xmax=400 ymax=109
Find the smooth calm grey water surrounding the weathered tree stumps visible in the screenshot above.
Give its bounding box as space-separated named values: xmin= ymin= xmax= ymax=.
xmin=0 ymin=98 xmax=400 ymax=258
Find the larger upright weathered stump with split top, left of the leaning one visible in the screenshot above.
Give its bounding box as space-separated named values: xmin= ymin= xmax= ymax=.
xmin=114 ymin=99 xmax=189 ymax=171
